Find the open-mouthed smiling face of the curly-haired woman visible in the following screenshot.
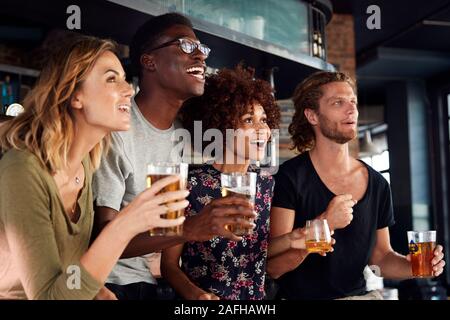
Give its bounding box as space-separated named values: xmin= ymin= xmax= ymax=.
xmin=234 ymin=102 xmax=271 ymax=160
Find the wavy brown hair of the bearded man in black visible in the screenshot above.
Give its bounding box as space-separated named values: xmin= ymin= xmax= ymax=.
xmin=289 ymin=71 xmax=356 ymax=153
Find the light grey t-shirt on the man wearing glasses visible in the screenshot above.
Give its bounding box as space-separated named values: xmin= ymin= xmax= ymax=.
xmin=93 ymin=99 xmax=180 ymax=285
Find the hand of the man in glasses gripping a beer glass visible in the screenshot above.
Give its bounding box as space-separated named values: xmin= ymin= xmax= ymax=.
xmin=183 ymin=196 xmax=256 ymax=241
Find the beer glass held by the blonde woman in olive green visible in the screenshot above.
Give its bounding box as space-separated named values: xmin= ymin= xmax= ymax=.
xmin=146 ymin=162 xmax=188 ymax=236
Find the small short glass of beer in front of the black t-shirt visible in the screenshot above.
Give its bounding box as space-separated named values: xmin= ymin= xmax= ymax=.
xmin=305 ymin=219 xmax=331 ymax=253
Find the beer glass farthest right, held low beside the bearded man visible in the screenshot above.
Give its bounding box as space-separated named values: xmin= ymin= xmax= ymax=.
xmin=408 ymin=231 xmax=436 ymax=278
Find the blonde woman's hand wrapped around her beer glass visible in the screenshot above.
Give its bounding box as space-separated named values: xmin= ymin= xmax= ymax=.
xmin=119 ymin=176 xmax=189 ymax=237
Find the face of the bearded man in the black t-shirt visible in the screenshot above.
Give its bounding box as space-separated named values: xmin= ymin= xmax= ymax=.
xmin=313 ymin=82 xmax=358 ymax=144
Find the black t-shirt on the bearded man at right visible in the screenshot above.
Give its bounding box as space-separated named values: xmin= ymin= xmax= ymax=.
xmin=272 ymin=152 xmax=394 ymax=299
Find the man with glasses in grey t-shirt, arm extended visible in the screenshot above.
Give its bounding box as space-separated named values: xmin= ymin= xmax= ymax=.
xmin=93 ymin=13 xmax=254 ymax=300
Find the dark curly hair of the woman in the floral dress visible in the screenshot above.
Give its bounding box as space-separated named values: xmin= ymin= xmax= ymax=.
xmin=179 ymin=65 xmax=280 ymax=150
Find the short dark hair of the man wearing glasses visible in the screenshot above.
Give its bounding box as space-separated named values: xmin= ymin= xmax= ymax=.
xmin=130 ymin=12 xmax=193 ymax=76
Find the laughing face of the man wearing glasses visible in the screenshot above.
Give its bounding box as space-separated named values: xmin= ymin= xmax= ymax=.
xmin=148 ymin=25 xmax=206 ymax=100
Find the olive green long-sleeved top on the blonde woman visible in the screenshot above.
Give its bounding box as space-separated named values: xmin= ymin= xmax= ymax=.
xmin=0 ymin=149 xmax=103 ymax=299
